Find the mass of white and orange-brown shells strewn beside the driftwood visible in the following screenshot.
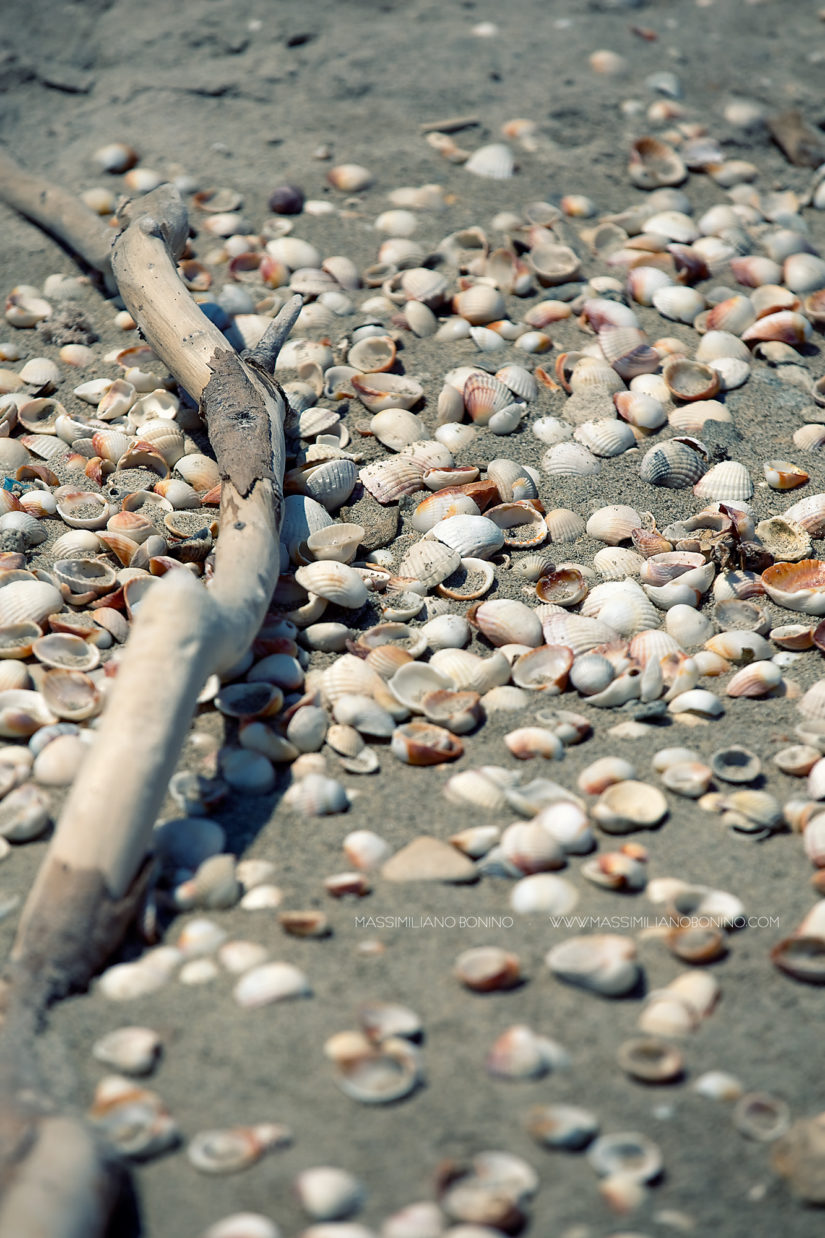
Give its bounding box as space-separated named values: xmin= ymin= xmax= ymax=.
xmin=0 ymin=87 xmax=825 ymax=1238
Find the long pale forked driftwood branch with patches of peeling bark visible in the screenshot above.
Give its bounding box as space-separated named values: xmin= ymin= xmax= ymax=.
xmin=0 ymin=154 xmax=301 ymax=1238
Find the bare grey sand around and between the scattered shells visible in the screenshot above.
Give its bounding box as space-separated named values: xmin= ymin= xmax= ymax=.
xmin=0 ymin=0 xmax=825 ymax=1238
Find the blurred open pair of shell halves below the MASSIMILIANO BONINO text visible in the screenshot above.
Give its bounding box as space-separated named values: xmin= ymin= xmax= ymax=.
xmin=325 ymin=1032 xmax=424 ymax=1104
